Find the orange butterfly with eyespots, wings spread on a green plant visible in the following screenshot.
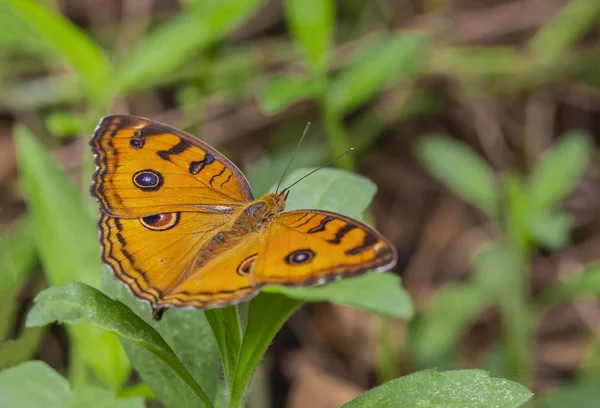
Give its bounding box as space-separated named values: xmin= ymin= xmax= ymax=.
xmin=90 ymin=115 xmax=397 ymax=319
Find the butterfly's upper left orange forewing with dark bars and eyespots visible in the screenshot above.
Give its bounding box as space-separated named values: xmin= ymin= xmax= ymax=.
xmin=90 ymin=115 xmax=253 ymax=217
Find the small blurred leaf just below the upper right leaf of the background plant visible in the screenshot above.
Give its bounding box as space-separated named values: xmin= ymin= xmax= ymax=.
xmin=528 ymin=212 xmax=571 ymax=249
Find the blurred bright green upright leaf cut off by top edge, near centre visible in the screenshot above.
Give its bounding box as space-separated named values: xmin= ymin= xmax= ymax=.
xmin=283 ymin=0 xmax=335 ymax=74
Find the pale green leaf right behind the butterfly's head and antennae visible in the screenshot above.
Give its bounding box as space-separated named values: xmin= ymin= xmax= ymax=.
xmin=271 ymin=168 xmax=377 ymax=220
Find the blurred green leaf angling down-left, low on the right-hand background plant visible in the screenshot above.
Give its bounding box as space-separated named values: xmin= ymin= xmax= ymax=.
xmin=409 ymin=283 xmax=494 ymax=366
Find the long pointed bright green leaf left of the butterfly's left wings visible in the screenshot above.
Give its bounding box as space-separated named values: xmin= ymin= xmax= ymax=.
xmin=15 ymin=127 xmax=100 ymax=287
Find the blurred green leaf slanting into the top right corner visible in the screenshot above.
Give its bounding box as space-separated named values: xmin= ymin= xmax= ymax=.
xmin=530 ymin=0 xmax=600 ymax=64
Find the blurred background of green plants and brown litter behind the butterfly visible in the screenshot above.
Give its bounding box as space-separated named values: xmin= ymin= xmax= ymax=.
xmin=0 ymin=0 xmax=600 ymax=408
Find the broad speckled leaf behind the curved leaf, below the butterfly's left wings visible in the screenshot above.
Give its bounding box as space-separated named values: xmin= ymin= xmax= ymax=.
xmin=102 ymin=268 xmax=220 ymax=407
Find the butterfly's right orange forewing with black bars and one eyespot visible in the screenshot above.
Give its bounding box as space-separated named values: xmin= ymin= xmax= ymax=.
xmin=251 ymin=210 xmax=397 ymax=286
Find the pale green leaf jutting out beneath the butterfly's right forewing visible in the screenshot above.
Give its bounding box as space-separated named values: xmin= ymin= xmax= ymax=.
xmin=262 ymin=273 xmax=413 ymax=319
